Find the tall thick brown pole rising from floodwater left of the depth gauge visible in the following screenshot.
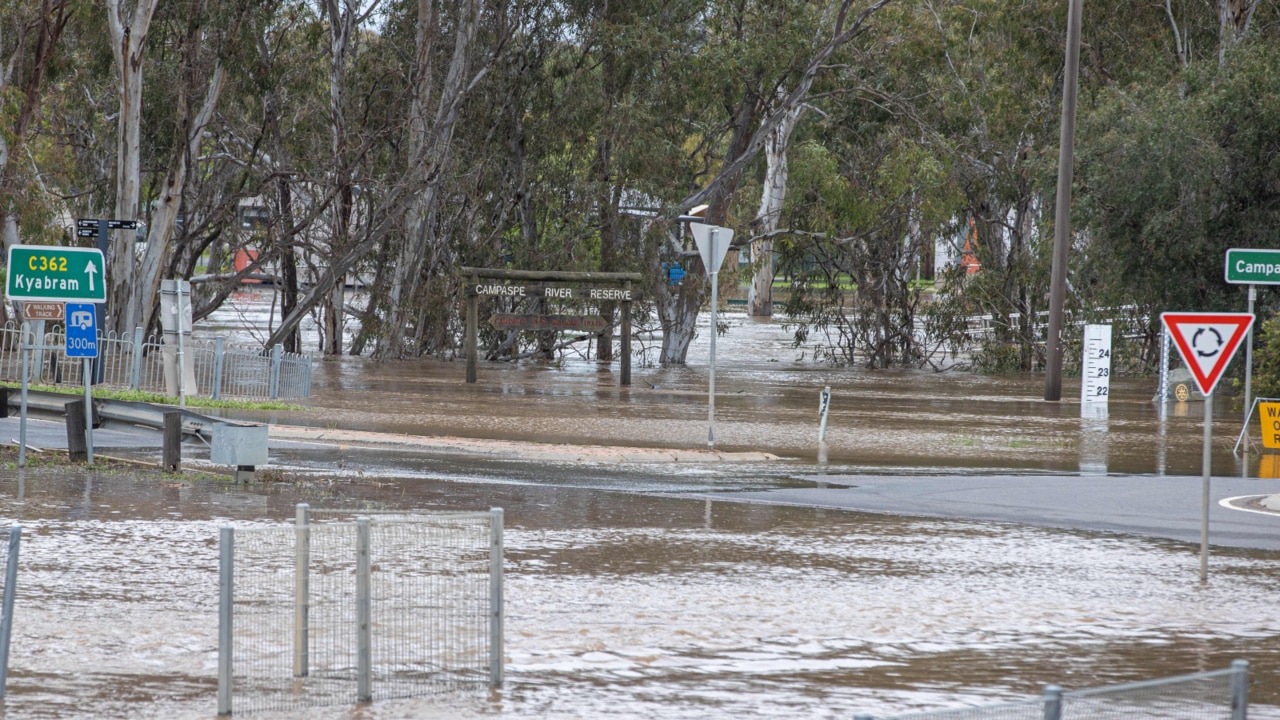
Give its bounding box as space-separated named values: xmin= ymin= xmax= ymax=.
xmin=1044 ymin=0 xmax=1084 ymax=402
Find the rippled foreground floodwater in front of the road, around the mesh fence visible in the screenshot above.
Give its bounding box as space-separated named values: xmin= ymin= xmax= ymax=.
xmin=0 ymin=470 xmax=1280 ymax=720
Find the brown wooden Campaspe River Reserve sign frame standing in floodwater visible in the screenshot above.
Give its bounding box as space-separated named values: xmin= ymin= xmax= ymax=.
xmin=461 ymin=268 xmax=643 ymax=386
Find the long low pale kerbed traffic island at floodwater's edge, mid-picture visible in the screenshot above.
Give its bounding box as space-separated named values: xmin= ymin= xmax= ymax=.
xmin=269 ymin=425 xmax=780 ymax=464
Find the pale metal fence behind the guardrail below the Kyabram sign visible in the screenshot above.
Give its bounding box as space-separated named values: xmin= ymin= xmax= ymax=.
xmin=0 ymin=323 xmax=311 ymax=400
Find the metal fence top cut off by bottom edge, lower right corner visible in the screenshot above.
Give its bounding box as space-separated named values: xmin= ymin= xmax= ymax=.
xmin=854 ymin=660 xmax=1249 ymax=720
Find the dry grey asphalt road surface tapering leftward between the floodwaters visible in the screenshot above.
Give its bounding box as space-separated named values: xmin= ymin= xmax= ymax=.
xmin=699 ymin=474 xmax=1280 ymax=550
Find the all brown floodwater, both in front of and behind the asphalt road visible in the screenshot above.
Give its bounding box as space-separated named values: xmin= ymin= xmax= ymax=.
xmin=0 ymin=295 xmax=1280 ymax=720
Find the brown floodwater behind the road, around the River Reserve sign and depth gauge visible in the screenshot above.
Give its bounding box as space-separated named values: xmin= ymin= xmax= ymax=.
xmin=217 ymin=297 xmax=1258 ymax=475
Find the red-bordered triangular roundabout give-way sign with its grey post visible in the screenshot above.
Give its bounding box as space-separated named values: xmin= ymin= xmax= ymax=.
xmin=1160 ymin=313 xmax=1253 ymax=583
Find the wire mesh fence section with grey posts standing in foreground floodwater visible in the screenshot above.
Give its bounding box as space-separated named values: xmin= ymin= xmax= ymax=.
xmin=218 ymin=505 xmax=503 ymax=715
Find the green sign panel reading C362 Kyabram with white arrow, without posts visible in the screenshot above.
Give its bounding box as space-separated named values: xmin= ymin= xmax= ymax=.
xmin=5 ymin=245 xmax=106 ymax=302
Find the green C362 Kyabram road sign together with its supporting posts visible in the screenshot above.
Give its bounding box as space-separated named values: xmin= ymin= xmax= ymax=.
xmin=5 ymin=240 xmax=106 ymax=468
